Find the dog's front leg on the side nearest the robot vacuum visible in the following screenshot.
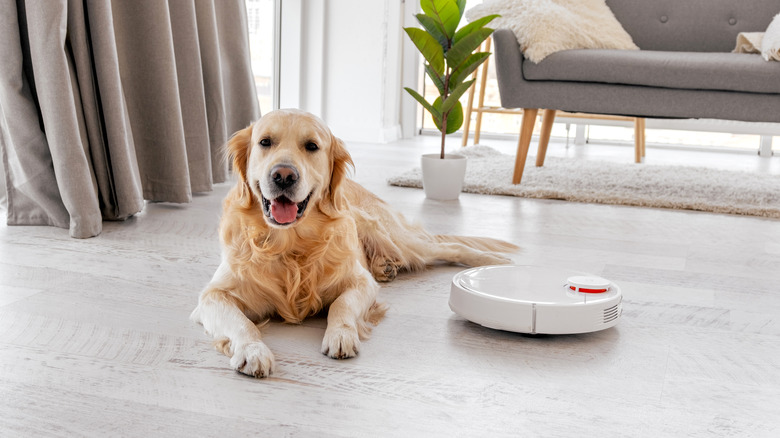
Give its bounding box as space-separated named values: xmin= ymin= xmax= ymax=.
xmin=320 ymin=262 xmax=379 ymax=359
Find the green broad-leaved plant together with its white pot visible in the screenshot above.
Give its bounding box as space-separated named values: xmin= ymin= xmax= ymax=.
xmin=404 ymin=0 xmax=498 ymax=199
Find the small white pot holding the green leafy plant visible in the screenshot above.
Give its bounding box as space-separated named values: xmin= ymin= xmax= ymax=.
xmin=422 ymin=154 xmax=466 ymax=201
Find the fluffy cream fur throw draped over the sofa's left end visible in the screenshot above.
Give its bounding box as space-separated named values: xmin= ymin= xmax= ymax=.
xmin=466 ymin=0 xmax=639 ymax=63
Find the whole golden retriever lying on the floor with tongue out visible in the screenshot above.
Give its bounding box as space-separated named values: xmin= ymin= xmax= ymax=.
xmin=191 ymin=110 xmax=517 ymax=377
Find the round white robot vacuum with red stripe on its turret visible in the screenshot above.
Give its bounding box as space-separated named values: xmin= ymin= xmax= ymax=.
xmin=450 ymin=265 xmax=623 ymax=334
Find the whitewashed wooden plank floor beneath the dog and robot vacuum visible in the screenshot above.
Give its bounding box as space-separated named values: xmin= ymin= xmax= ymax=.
xmin=0 ymin=139 xmax=780 ymax=437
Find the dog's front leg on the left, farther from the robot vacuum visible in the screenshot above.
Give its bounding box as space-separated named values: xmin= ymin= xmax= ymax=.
xmin=190 ymin=262 xmax=274 ymax=377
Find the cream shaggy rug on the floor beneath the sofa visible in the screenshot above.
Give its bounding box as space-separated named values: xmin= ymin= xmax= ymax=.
xmin=388 ymin=145 xmax=780 ymax=218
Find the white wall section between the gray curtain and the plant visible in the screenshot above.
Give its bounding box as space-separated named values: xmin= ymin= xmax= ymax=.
xmin=279 ymin=0 xmax=404 ymax=143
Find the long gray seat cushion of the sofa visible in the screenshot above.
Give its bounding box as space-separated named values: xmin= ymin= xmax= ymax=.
xmin=523 ymin=49 xmax=780 ymax=93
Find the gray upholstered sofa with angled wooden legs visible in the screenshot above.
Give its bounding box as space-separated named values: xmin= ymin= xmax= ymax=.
xmin=493 ymin=0 xmax=780 ymax=184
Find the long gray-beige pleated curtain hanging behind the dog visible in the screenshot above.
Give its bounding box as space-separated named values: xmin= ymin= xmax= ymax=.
xmin=0 ymin=0 xmax=260 ymax=238
